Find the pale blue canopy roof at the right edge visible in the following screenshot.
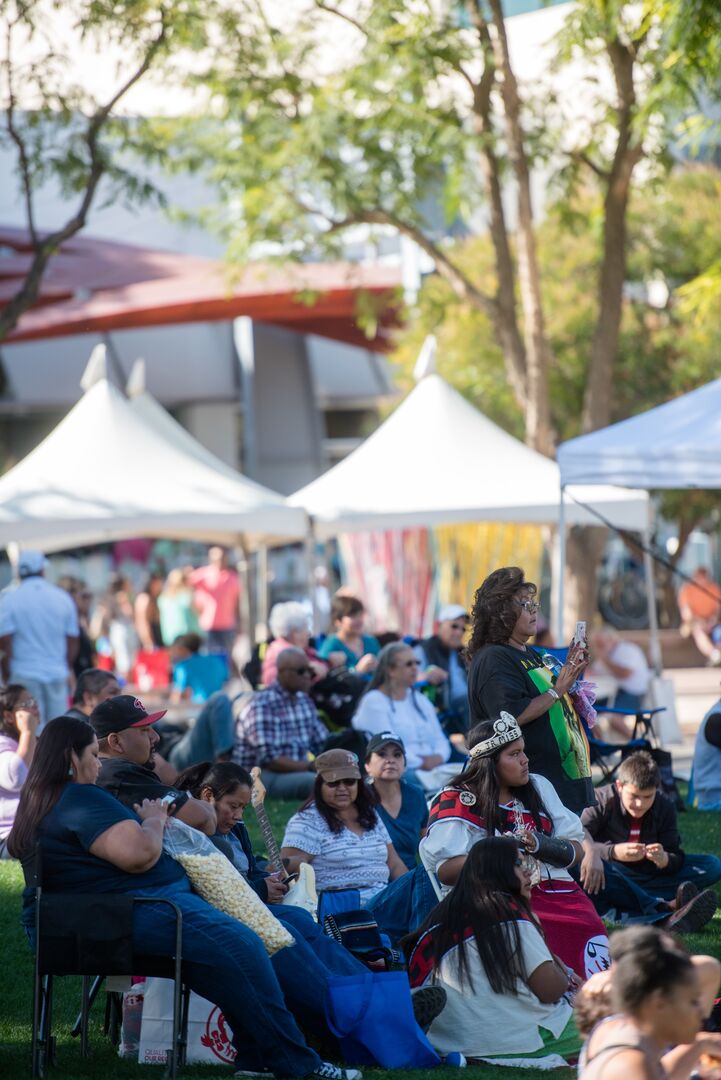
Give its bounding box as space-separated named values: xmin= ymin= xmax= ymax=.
xmin=557 ymin=379 xmax=721 ymax=489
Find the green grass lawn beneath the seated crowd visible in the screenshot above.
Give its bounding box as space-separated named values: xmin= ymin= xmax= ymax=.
xmin=0 ymin=802 xmax=721 ymax=1080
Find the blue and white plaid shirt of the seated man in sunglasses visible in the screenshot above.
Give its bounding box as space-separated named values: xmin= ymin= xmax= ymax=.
xmin=233 ymin=679 xmax=328 ymax=769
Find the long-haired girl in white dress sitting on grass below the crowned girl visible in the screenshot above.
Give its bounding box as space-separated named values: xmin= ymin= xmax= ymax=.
xmin=404 ymin=837 xmax=581 ymax=1067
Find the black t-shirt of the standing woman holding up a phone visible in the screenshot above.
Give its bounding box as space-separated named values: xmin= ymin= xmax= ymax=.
xmin=468 ymin=645 xmax=596 ymax=814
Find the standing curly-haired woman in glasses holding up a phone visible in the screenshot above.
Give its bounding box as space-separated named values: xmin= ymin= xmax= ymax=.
xmin=466 ymin=566 xmax=596 ymax=814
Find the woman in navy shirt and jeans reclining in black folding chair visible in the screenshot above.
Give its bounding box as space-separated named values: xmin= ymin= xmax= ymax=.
xmin=8 ymin=716 xmax=361 ymax=1080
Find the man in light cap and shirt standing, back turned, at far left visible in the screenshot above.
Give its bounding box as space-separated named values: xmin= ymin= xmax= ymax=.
xmin=0 ymin=549 xmax=80 ymax=734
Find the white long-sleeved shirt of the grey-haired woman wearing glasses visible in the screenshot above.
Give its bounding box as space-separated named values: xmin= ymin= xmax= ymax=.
xmin=351 ymin=690 xmax=451 ymax=769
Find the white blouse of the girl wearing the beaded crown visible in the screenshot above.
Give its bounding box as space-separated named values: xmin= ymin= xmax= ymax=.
xmin=419 ymin=772 xmax=584 ymax=893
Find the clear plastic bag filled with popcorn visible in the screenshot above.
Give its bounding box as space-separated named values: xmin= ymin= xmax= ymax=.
xmin=163 ymin=818 xmax=294 ymax=956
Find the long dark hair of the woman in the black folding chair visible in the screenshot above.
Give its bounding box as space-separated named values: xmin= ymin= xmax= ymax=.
xmin=8 ymin=716 xmax=95 ymax=859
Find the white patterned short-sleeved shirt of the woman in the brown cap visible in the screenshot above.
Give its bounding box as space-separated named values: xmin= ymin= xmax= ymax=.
xmin=283 ymin=806 xmax=391 ymax=903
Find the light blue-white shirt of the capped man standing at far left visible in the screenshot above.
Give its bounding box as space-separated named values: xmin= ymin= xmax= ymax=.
xmin=0 ymin=575 xmax=79 ymax=683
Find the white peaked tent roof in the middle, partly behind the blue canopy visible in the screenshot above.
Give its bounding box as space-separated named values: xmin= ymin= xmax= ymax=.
xmin=288 ymin=374 xmax=648 ymax=538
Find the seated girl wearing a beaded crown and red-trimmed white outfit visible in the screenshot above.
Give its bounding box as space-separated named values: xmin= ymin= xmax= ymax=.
xmin=420 ymin=713 xmax=608 ymax=978
